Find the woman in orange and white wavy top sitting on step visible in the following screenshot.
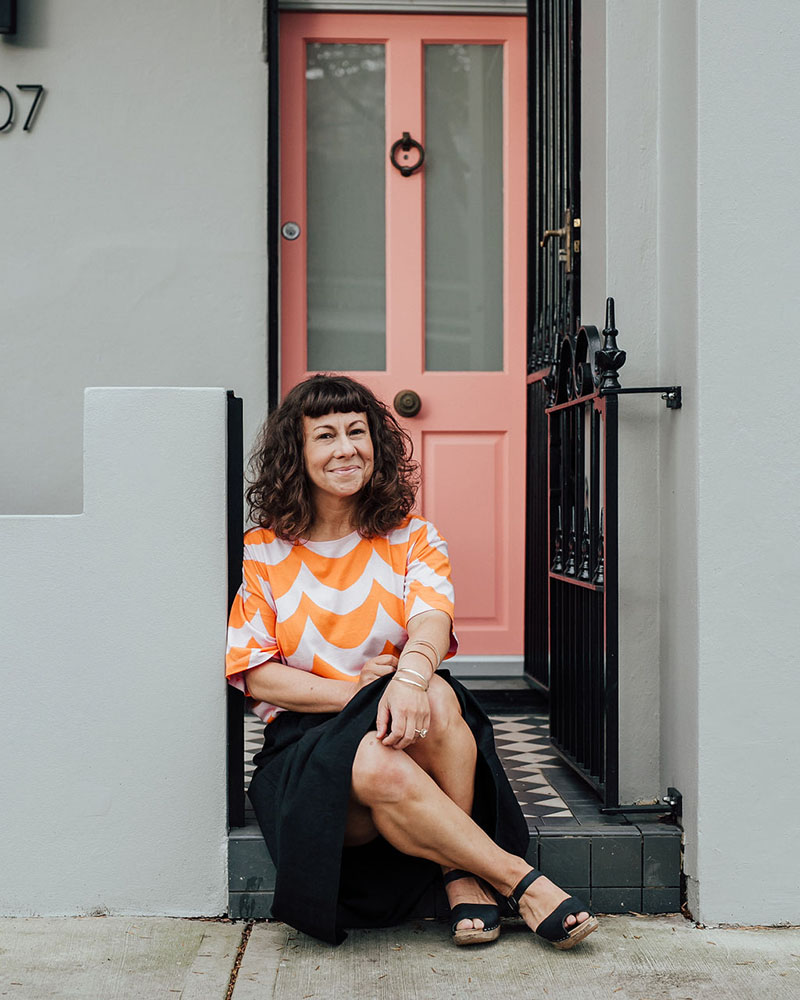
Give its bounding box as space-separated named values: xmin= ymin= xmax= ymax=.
xmin=222 ymin=375 xmax=597 ymax=948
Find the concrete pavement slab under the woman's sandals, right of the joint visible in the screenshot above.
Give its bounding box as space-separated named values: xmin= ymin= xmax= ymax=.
xmin=233 ymin=915 xmax=800 ymax=1000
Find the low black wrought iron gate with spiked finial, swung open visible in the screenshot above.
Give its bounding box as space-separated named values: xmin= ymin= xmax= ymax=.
xmin=546 ymin=316 xmax=624 ymax=806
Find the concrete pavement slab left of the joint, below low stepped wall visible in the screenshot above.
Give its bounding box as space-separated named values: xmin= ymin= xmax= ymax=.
xmin=0 ymin=917 xmax=244 ymax=1000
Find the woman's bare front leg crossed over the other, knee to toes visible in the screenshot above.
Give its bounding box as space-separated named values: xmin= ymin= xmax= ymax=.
xmin=352 ymin=733 xmax=588 ymax=929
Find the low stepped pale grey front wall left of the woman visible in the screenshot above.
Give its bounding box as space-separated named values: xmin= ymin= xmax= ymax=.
xmin=0 ymin=389 xmax=227 ymax=916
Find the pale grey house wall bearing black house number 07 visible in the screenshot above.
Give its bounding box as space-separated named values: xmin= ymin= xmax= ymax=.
xmin=0 ymin=0 xmax=266 ymax=513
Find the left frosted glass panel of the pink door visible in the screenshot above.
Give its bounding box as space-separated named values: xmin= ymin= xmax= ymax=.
xmin=306 ymin=42 xmax=386 ymax=371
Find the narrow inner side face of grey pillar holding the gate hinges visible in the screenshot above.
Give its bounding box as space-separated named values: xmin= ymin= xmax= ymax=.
xmin=657 ymin=0 xmax=699 ymax=910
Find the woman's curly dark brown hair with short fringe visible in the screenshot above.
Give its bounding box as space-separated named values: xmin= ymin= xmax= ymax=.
xmin=246 ymin=375 xmax=419 ymax=542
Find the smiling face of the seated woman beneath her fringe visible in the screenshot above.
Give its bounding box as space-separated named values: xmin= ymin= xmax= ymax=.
xmin=303 ymin=413 xmax=374 ymax=503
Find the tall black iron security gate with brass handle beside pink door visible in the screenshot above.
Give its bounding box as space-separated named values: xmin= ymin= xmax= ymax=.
xmin=525 ymin=0 xmax=580 ymax=690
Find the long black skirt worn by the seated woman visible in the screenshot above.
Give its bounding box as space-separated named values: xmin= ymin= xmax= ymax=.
xmin=248 ymin=670 xmax=528 ymax=944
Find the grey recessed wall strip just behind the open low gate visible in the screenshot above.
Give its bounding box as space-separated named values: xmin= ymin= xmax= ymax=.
xmin=581 ymin=0 xmax=664 ymax=802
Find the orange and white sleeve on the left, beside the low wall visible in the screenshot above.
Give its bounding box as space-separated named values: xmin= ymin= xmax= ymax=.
xmin=225 ymin=546 xmax=280 ymax=692
